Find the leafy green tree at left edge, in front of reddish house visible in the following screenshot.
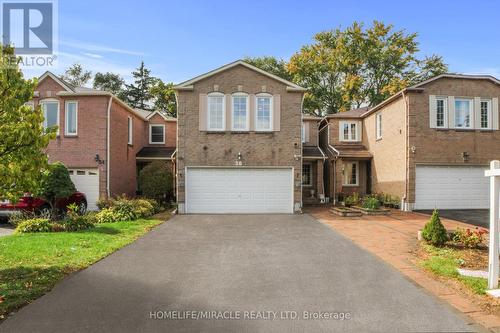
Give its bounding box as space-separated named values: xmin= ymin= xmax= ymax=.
xmin=0 ymin=45 xmax=56 ymax=201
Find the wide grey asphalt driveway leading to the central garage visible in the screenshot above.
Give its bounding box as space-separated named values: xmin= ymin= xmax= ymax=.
xmin=0 ymin=215 xmax=474 ymax=332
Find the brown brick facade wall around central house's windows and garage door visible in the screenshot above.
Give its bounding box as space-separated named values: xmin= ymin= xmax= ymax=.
xmin=177 ymin=66 xmax=302 ymax=211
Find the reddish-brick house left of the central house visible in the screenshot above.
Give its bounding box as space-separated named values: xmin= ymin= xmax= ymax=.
xmin=32 ymin=72 xmax=176 ymax=209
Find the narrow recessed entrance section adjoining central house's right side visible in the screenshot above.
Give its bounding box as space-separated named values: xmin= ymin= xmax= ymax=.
xmin=302 ymin=115 xmax=327 ymax=205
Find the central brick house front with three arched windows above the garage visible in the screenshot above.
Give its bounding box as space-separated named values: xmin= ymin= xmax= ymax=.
xmin=175 ymin=61 xmax=305 ymax=213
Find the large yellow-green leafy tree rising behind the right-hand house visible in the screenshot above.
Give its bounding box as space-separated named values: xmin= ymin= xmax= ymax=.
xmin=288 ymin=21 xmax=447 ymax=113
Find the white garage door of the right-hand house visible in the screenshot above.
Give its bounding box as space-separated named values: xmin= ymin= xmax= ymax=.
xmin=415 ymin=166 xmax=489 ymax=209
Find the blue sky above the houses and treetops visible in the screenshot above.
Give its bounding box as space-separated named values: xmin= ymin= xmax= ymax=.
xmin=21 ymin=0 xmax=500 ymax=83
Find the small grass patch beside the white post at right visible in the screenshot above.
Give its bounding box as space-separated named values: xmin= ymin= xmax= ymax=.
xmin=422 ymin=244 xmax=488 ymax=295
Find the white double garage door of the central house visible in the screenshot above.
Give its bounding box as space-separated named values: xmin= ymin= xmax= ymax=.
xmin=186 ymin=168 xmax=293 ymax=214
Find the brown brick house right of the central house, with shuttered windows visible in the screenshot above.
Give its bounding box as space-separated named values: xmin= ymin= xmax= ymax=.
xmin=320 ymin=74 xmax=500 ymax=210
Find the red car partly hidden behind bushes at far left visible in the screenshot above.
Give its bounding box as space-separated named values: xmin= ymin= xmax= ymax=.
xmin=0 ymin=192 xmax=87 ymax=217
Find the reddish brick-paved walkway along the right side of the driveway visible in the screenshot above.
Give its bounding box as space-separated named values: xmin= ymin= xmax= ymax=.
xmin=305 ymin=207 xmax=500 ymax=332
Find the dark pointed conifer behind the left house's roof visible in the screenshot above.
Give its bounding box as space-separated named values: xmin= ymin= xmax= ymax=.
xmin=126 ymin=61 xmax=156 ymax=110
